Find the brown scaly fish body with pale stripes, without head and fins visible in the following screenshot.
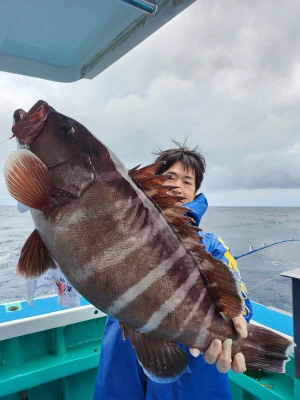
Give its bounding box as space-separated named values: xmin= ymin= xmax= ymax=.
xmin=27 ymin=121 xmax=230 ymax=350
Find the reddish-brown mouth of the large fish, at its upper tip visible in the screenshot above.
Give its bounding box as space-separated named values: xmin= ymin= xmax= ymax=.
xmin=12 ymin=100 xmax=54 ymax=145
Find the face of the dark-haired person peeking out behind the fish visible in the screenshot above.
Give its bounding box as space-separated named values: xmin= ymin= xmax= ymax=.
xmin=163 ymin=161 xmax=196 ymax=205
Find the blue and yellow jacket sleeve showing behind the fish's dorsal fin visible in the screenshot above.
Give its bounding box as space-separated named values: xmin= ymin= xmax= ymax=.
xmin=201 ymin=232 xmax=253 ymax=322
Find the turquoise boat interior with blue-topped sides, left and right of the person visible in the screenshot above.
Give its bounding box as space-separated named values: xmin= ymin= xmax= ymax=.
xmin=0 ymin=296 xmax=300 ymax=400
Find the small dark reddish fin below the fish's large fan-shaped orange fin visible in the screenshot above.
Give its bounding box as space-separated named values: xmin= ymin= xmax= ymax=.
xmin=17 ymin=229 xmax=56 ymax=278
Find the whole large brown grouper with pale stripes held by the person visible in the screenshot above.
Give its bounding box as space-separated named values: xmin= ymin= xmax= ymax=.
xmin=4 ymin=101 xmax=293 ymax=379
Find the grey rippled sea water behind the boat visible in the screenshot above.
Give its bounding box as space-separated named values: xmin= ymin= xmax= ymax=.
xmin=0 ymin=206 xmax=300 ymax=312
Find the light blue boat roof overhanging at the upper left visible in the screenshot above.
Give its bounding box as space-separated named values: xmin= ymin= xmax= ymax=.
xmin=0 ymin=0 xmax=195 ymax=82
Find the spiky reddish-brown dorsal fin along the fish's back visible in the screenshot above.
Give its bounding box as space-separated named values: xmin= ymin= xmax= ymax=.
xmin=130 ymin=163 xmax=243 ymax=318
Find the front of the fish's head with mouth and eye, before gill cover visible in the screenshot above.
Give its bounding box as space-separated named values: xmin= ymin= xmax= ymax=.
xmin=12 ymin=100 xmax=87 ymax=168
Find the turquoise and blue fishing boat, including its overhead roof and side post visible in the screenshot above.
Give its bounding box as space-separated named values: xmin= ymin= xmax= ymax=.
xmin=0 ymin=0 xmax=300 ymax=400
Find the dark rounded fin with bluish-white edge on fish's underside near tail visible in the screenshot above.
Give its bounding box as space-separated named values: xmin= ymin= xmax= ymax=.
xmin=120 ymin=323 xmax=187 ymax=383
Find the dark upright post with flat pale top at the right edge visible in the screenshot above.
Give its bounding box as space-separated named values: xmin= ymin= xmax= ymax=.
xmin=281 ymin=268 xmax=300 ymax=379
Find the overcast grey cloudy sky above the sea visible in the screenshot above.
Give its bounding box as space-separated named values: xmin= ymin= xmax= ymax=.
xmin=0 ymin=0 xmax=300 ymax=206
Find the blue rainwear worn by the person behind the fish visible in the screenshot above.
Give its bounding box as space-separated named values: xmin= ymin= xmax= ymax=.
xmin=94 ymin=194 xmax=252 ymax=400
